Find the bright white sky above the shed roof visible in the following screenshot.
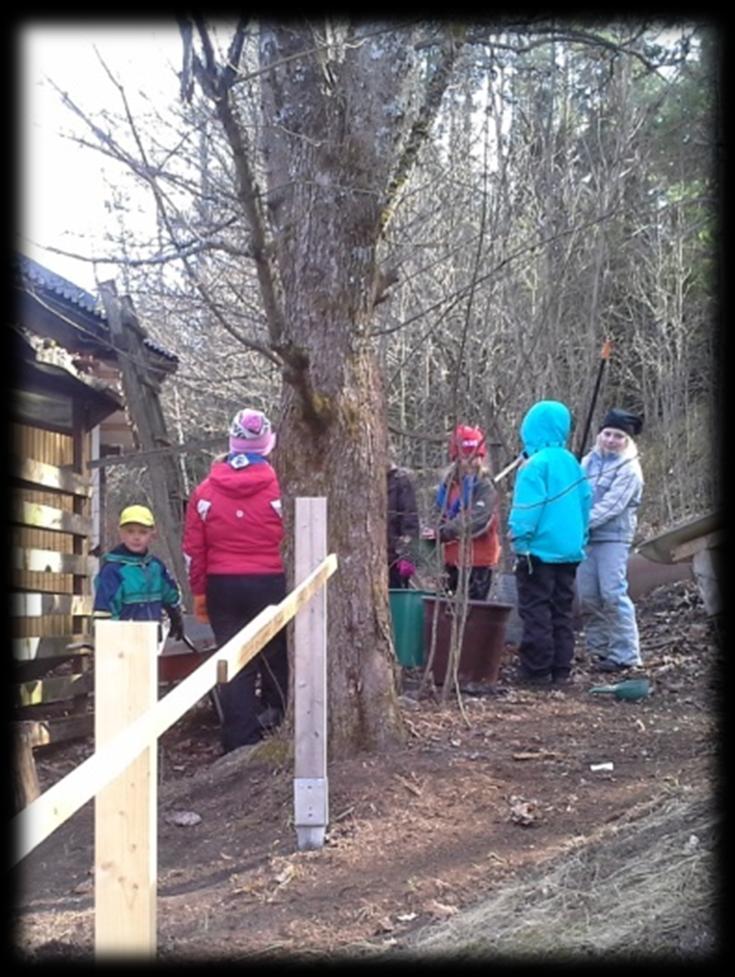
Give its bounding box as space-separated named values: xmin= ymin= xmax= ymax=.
xmin=16 ymin=20 xmax=181 ymax=290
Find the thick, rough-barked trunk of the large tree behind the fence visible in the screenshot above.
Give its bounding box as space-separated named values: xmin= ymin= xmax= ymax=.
xmin=261 ymin=23 xmax=460 ymax=755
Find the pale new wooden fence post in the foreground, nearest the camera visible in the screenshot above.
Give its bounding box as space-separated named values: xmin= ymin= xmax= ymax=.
xmin=94 ymin=620 xmax=158 ymax=957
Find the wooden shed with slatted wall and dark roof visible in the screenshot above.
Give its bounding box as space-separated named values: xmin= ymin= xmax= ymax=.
xmin=10 ymin=256 xmax=178 ymax=804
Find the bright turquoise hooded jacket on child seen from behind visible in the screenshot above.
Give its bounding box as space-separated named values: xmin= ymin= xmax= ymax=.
xmin=508 ymin=400 xmax=592 ymax=563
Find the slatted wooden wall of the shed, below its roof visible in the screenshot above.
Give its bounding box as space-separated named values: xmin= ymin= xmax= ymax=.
xmin=10 ymin=423 xmax=97 ymax=776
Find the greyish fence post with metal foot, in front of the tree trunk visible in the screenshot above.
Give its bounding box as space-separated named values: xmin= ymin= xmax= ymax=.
xmin=294 ymin=498 xmax=329 ymax=850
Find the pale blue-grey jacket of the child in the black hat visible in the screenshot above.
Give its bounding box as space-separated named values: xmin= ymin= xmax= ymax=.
xmin=582 ymin=438 xmax=643 ymax=545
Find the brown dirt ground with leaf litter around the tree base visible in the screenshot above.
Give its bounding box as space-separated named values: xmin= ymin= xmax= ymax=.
xmin=14 ymin=581 xmax=719 ymax=961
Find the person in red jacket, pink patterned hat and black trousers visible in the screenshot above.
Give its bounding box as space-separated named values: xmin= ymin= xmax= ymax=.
xmin=184 ymin=408 xmax=288 ymax=752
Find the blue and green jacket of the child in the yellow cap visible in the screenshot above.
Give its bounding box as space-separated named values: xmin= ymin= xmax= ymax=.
xmin=93 ymin=544 xmax=181 ymax=621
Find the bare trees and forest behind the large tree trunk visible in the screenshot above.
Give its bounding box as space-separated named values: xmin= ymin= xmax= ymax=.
xmin=34 ymin=23 xmax=721 ymax=532
